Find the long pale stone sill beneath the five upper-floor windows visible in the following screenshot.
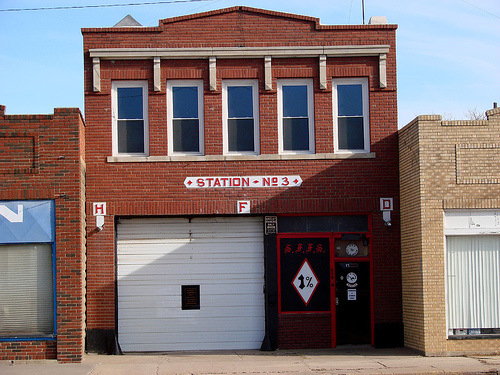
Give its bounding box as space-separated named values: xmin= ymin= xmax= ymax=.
xmin=107 ymin=152 xmax=375 ymax=163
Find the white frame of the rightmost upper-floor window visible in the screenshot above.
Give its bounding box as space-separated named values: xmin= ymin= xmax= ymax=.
xmin=332 ymin=78 xmax=370 ymax=154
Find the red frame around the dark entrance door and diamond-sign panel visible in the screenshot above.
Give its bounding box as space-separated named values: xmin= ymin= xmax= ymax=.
xmin=277 ymin=232 xmax=375 ymax=348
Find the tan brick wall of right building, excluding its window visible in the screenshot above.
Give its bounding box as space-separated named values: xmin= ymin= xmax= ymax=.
xmin=399 ymin=109 xmax=500 ymax=355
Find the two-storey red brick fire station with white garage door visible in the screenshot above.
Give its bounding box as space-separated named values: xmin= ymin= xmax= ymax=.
xmin=82 ymin=7 xmax=402 ymax=352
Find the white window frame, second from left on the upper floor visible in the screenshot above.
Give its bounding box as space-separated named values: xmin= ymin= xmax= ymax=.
xmin=167 ymin=80 xmax=205 ymax=156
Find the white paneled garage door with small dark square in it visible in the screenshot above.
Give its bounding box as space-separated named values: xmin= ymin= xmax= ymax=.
xmin=117 ymin=217 xmax=264 ymax=351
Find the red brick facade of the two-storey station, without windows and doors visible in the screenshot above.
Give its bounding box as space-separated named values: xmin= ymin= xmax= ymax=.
xmin=82 ymin=7 xmax=402 ymax=347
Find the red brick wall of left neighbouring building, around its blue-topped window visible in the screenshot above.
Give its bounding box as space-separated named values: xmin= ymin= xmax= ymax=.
xmin=0 ymin=106 xmax=85 ymax=362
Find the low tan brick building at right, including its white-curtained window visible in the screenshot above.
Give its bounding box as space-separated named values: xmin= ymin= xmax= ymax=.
xmin=399 ymin=108 xmax=500 ymax=355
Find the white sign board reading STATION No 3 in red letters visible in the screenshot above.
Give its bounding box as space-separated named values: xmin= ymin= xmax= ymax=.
xmin=184 ymin=175 xmax=302 ymax=189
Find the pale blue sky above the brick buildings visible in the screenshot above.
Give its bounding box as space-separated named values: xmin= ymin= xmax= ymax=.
xmin=0 ymin=0 xmax=500 ymax=127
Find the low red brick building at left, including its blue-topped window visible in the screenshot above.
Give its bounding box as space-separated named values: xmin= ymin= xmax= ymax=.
xmin=0 ymin=106 xmax=85 ymax=362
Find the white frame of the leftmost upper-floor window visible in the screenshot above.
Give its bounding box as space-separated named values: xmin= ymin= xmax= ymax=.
xmin=111 ymin=81 xmax=149 ymax=156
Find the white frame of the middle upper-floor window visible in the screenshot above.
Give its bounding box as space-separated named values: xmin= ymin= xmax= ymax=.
xmin=222 ymin=79 xmax=260 ymax=155
